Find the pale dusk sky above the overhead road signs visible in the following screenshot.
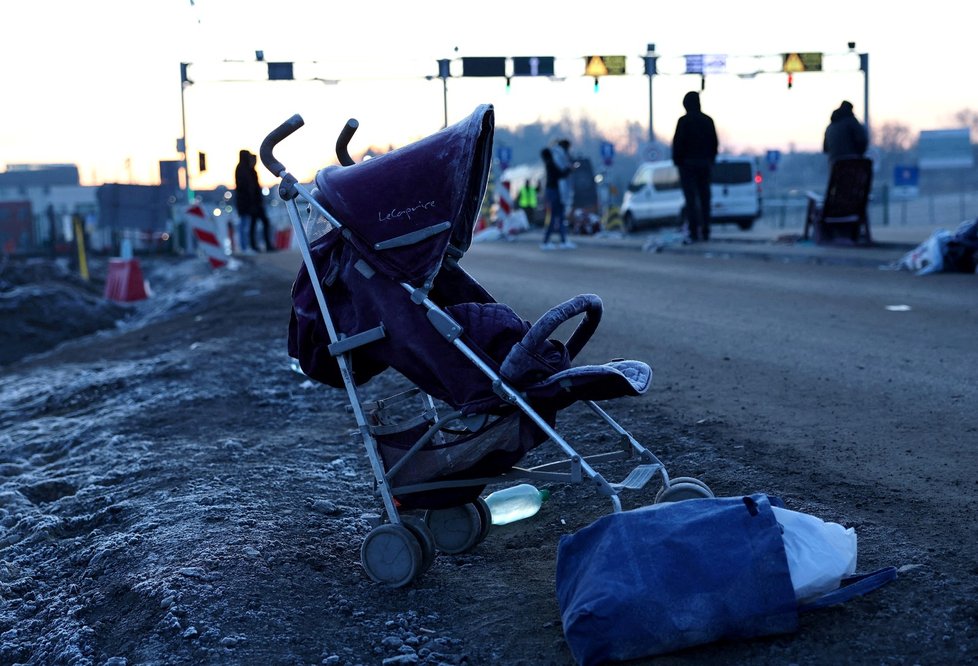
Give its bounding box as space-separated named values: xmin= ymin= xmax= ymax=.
xmin=0 ymin=0 xmax=978 ymax=188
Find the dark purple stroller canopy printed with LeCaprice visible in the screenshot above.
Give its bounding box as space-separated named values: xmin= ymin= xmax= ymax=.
xmin=315 ymin=104 xmax=495 ymax=286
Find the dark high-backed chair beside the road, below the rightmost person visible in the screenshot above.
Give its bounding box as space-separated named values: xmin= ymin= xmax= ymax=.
xmin=802 ymin=156 xmax=873 ymax=245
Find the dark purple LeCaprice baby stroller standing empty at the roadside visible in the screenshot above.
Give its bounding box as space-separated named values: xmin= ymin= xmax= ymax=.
xmin=261 ymin=104 xmax=713 ymax=587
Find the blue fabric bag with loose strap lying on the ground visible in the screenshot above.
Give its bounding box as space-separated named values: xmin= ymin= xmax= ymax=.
xmin=556 ymin=493 xmax=896 ymax=665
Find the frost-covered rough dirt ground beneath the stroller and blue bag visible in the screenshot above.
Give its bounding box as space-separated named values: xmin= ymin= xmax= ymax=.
xmin=0 ymin=252 xmax=978 ymax=666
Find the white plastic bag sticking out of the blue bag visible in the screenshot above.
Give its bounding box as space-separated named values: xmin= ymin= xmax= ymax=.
xmin=771 ymin=506 xmax=856 ymax=604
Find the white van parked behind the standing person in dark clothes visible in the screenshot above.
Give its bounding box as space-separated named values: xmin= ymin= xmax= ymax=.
xmin=621 ymin=155 xmax=761 ymax=231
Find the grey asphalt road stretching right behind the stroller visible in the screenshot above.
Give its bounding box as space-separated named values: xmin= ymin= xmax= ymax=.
xmin=452 ymin=242 xmax=978 ymax=539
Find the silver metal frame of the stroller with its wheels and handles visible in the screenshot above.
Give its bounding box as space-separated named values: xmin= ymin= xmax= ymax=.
xmin=260 ymin=114 xmax=713 ymax=587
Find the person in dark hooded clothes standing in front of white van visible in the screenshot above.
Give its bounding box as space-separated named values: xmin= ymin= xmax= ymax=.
xmin=672 ymin=91 xmax=720 ymax=242
